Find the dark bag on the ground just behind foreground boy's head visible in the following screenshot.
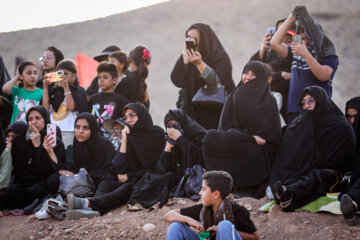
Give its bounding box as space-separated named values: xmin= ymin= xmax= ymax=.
xmin=170 ymin=165 xmax=205 ymax=201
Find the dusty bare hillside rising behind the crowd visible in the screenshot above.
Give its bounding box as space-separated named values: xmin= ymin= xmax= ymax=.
xmin=0 ymin=0 xmax=360 ymax=126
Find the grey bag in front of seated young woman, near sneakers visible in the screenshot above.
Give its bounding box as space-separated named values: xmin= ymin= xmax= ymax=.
xmin=59 ymin=168 xmax=95 ymax=198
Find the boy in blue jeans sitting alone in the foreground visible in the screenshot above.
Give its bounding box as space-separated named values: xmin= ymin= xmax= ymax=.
xmin=164 ymin=171 xmax=259 ymax=240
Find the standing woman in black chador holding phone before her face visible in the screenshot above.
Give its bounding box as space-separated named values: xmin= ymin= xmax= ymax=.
xmin=171 ymin=23 xmax=235 ymax=129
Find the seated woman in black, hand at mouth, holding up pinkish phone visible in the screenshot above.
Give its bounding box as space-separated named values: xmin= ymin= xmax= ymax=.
xmin=0 ymin=105 xmax=66 ymax=209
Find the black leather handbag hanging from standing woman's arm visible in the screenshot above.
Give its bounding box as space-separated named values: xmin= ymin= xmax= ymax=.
xmin=191 ymin=76 xmax=225 ymax=108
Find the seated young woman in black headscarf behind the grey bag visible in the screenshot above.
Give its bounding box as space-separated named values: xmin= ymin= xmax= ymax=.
xmin=61 ymin=112 xmax=116 ymax=195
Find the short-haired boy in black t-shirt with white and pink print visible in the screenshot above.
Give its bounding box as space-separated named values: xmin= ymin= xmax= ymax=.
xmin=88 ymin=62 xmax=128 ymax=137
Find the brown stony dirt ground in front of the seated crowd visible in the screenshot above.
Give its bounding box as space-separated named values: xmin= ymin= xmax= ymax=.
xmin=0 ymin=198 xmax=360 ymax=240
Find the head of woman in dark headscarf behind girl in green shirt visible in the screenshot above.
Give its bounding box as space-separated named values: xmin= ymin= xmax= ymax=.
xmin=36 ymin=46 xmax=64 ymax=88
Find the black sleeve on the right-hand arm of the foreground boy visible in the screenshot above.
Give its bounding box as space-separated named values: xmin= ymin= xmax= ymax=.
xmin=233 ymin=203 xmax=256 ymax=234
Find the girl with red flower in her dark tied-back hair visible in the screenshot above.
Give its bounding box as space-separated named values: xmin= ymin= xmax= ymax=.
xmin=115 ymin=45 xmax=151 ymax=109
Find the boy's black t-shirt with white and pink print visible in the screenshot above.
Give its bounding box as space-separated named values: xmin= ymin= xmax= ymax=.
xmin=88 ymin=92 xmax=129 ymax=135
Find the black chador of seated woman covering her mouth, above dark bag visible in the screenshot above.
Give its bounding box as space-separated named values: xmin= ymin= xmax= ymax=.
xmin=158 ymin=110 xmax=206 ymax=176
